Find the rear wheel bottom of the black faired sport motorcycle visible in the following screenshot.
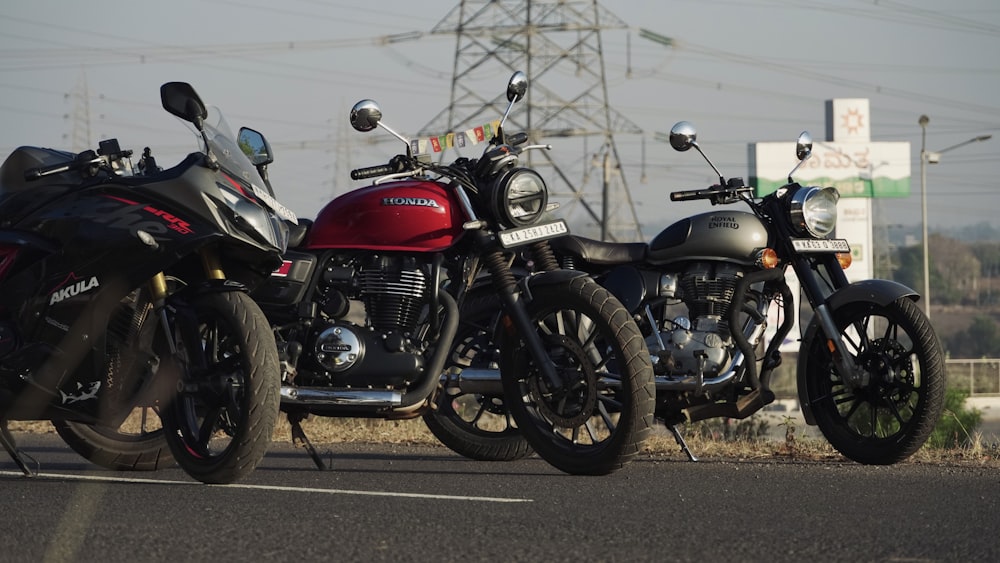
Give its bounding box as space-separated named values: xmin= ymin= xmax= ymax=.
xmin=52 ymin=407 xmax=174 ymax=471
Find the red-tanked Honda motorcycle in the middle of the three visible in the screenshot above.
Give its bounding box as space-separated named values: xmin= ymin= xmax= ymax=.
xmin=244 ymin=72 xmax=653 ymax=474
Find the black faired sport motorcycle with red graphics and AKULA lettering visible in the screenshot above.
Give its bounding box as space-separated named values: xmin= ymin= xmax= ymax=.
xmin=0 ymin=82 xmax=295 ymax=483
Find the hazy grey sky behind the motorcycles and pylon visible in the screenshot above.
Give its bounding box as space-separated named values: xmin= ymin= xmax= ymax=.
xmin=0 ymin=0 xmax=1000 ymax=239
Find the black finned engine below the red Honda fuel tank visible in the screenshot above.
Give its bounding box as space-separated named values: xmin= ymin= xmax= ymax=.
xmin=296 ymin=256 xmax=427 ymax=387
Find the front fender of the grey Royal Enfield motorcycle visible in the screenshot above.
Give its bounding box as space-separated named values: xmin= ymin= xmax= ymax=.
xmin=796 ymin=280 xmax=920 ymax=425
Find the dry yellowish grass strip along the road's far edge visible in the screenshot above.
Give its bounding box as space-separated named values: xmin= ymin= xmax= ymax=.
xmin=10 ymin=417 xmax=1000 ymax=468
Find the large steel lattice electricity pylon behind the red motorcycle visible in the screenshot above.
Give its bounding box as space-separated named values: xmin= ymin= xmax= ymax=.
xmin=420 ymin=0 xmax=644 ymax=241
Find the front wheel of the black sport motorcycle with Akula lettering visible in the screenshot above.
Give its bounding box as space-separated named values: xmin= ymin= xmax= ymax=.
xmin=160 ymin=291 xmax=280 ymax=484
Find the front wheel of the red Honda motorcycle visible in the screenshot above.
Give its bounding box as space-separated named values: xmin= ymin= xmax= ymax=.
xmin=500 ymin=277 xmax=656 ymax=475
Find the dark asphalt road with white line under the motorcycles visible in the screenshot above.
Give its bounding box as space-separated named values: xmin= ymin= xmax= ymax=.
xmin=0 ymin=434 xmax=1000 ymax=563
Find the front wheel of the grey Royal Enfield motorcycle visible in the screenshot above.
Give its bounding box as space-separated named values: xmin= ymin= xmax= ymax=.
xmin=801 ymin=297 xmax=945 ymax=465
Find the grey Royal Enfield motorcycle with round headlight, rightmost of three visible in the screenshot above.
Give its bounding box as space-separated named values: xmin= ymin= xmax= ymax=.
xmin=425 ymin=122 xmax=945 ymax=464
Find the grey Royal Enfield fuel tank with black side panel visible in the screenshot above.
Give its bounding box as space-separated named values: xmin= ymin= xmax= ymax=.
xmin=649 ymin=211 xmax=768 ymax=265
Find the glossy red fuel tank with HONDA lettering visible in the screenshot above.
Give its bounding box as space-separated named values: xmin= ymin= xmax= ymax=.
xmin=305 ymin=180 xmax=465 ymax=252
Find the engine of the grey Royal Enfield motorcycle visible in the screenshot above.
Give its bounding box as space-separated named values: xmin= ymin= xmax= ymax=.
xmin=647 ymin=262 xmax=742 ymax=377
